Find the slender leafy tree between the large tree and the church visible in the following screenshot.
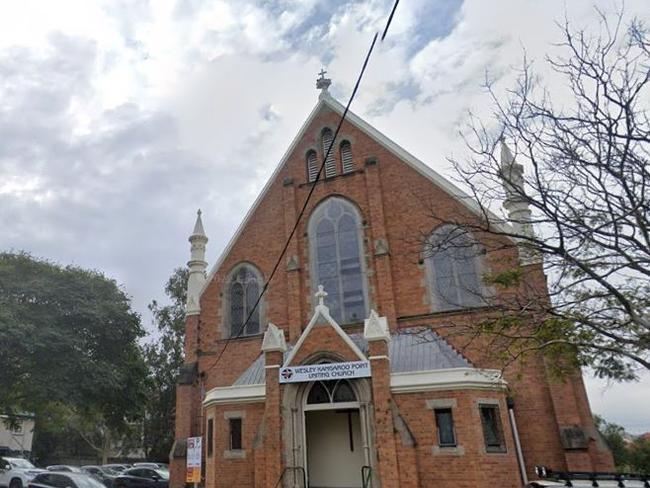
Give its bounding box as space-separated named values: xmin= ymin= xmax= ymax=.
xmin=144 ymin=268 xmax=188 ymax=461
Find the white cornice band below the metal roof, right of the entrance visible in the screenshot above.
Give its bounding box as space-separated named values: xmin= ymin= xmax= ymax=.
xmin=390 ymin=368 xmax=506 ymax=393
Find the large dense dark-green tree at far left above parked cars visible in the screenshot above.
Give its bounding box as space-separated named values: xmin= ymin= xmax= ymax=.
xmin=0 ymin=252 xmax=146 ymax=460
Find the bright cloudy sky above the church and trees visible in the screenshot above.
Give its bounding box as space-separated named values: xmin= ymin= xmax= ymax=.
xmin=0 ymin=0 xmax=650 ymax=433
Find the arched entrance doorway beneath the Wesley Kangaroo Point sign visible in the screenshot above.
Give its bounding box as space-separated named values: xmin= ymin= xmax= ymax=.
xmin=304 ymin=380 xmax=366 ymax=488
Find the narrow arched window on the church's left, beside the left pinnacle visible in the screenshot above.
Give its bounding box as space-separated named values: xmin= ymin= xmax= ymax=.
xmin=227 ymin=264 xmax=262 ymax=337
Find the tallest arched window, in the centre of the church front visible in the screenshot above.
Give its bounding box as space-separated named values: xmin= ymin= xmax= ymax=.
xmin=309 ymin=197 xmax=367 ymax=324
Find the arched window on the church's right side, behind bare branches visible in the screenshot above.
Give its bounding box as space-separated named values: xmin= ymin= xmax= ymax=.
xmin=426 ymin=225 xmax=484 ymax=310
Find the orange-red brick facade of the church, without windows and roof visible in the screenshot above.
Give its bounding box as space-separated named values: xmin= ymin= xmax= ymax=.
xmin=171 ymin=92 xmax=612 ymax=488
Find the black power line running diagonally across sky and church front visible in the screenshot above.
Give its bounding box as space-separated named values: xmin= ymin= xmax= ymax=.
xmin=206 ymin=0 xmax=399 ymax=372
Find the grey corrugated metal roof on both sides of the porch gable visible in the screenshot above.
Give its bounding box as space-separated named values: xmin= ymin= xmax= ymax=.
xmin=234 ymin=327 xmax=472 ymax=385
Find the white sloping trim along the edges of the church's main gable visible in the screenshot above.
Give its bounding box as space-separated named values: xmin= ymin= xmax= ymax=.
xmin=199 ymin=91 xmax=508 ymax=298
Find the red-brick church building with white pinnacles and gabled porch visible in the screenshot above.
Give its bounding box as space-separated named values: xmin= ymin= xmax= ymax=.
xmin=170 ymin=75 xmax=613 ymax=488
